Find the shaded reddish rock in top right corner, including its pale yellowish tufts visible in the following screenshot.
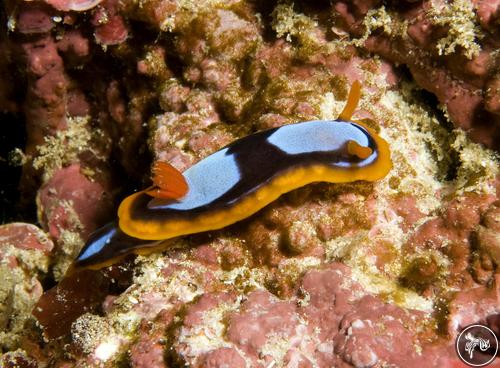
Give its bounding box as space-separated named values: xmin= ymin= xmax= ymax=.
xmin=334 ymin=1 xmax=500 ymax=150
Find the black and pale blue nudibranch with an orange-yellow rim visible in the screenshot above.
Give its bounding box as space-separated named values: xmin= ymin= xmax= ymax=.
xmin=74 ymin=82 xmax=392 ymax=268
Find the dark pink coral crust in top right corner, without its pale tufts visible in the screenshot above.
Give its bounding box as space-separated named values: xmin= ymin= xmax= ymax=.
xmin=335 ymin=1 xmax=500 ymax=149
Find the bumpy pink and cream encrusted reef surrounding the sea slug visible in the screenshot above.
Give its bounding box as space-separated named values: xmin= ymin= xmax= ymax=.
xmin=0 ymin=0 xmax=500 ymax=368
